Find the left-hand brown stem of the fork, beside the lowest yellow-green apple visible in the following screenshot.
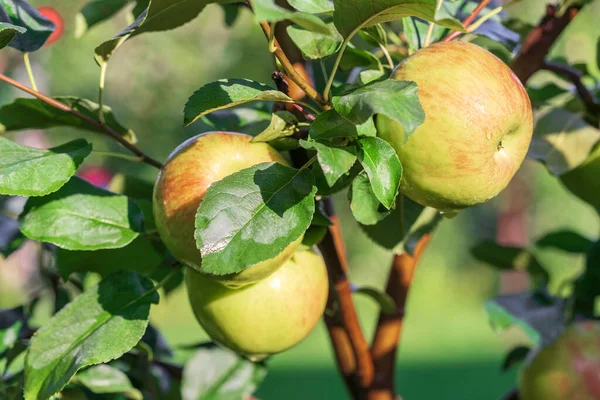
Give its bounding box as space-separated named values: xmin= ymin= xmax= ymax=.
xmin=320 ymin=199 xmax=373 ymax=392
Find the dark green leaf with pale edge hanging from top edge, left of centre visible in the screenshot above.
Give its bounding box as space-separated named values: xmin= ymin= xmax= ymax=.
xmin=95 ymin=0 xmax=217 ymax=64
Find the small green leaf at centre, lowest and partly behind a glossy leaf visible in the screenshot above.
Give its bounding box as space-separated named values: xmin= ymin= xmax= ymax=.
xmin=348 ymin=171 xmax=390 ymax=225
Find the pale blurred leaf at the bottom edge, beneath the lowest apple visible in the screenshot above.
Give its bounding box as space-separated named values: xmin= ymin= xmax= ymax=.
xmin=181 ymin=346 xmax=267 ymax=400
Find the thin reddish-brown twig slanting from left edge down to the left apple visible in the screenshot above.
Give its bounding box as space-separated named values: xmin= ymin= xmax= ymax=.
xmin=0 ymin=74 xmax=162 ymax=169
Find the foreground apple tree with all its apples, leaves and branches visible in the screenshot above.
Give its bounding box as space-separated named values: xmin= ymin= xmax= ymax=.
xmin=0 ymin=0 xmax=600 ymax=400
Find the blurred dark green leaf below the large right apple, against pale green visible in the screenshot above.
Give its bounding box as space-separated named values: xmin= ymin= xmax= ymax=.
xmin=471 ymin=240 xmax=550 ymax=287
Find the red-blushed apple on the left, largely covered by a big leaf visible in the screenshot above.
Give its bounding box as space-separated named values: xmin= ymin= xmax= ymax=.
xmin=153 ymin=132 xmax=302 ymax=285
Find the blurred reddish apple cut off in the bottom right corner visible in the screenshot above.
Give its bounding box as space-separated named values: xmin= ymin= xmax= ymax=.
xmin=519 ymin=321 xmax=600 ymax=400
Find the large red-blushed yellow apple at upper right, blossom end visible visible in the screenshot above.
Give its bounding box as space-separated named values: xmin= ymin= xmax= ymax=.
xmin=377 ymin=41 xmax=533 ymax=212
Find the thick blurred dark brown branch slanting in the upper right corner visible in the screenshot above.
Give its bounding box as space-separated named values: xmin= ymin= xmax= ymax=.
xmin=512 ymin=6 xmax=579 ymax=84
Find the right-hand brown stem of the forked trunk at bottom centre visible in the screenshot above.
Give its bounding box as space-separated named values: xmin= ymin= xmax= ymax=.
xmin=368 ymin=234 xmax=431 ymax=400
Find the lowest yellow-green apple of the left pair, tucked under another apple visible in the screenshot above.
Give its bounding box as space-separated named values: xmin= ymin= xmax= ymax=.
xmin=185 ymin=250 xmax=329 ymax=360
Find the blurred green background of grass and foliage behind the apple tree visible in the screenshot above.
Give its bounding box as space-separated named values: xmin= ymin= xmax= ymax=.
xmin=0 ymin=0 xmax=600 ymax=400
